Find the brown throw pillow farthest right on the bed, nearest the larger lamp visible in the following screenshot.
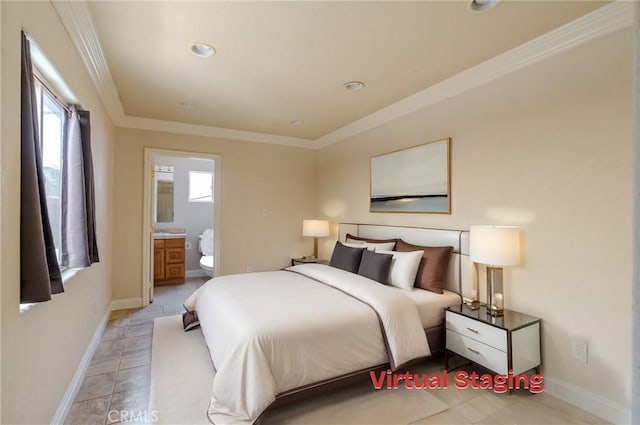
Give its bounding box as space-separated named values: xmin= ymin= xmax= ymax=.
xmin=396 ymin=239 xmax=453 ymax=294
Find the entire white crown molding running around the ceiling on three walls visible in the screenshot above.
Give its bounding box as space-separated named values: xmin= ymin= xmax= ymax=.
xmin=52 ymin=0 xmax=633 ymax=149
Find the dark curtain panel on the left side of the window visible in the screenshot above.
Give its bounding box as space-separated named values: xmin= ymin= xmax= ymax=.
xmin=20 ymin=33 xmax=64 ymax=303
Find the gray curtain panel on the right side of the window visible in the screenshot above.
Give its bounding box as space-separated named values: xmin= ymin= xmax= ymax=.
xmin=61 ymin=106 xmax=100 ymax=269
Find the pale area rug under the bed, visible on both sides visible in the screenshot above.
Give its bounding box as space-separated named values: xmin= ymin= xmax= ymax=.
xmin=149 ymin=315 xmax=447 ymax=425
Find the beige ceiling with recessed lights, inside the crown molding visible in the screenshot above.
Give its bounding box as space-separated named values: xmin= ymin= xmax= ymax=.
xmin=82 ymin=0 xmax=606 ymax=143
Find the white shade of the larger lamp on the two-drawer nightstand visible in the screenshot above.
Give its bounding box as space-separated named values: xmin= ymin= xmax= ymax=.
xmin=469 ymin=226 xmax=520 ymax=266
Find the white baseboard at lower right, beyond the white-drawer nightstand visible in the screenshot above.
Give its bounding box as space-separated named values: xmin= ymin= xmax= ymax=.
xmin=544 ymin=375 xmax=631 ymax=424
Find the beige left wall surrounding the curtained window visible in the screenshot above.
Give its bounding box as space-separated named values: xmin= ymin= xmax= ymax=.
xmin=0 ymin=2 xmax=114 ymax=424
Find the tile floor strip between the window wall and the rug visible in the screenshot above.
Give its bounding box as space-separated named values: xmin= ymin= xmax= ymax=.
xmin=65 ymin=278 xmax=207 ymax=425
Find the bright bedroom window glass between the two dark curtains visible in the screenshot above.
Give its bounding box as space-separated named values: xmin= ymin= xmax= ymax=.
xmin=34 ymin=75 xmax=67 ymax=263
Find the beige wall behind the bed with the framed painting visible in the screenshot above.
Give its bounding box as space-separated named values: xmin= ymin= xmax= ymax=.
xmin=318 ymin=30 xmax=633 ymax=416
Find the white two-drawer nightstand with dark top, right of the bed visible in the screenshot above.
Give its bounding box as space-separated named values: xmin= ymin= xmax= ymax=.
xmin=445 ymin=304 xmax=542 ymax=375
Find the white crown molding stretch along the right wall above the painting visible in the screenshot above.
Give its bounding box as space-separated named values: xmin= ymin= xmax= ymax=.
xmin=314 ymin=1 xmax=633 ymax=148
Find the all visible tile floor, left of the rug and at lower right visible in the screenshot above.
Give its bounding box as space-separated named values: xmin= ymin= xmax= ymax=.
xmin=65 ymin=278 xmax=608 ymax=425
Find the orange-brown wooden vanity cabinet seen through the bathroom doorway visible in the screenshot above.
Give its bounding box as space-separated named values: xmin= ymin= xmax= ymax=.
xmin=153 ymin=238 xmax=184 ymax=286
